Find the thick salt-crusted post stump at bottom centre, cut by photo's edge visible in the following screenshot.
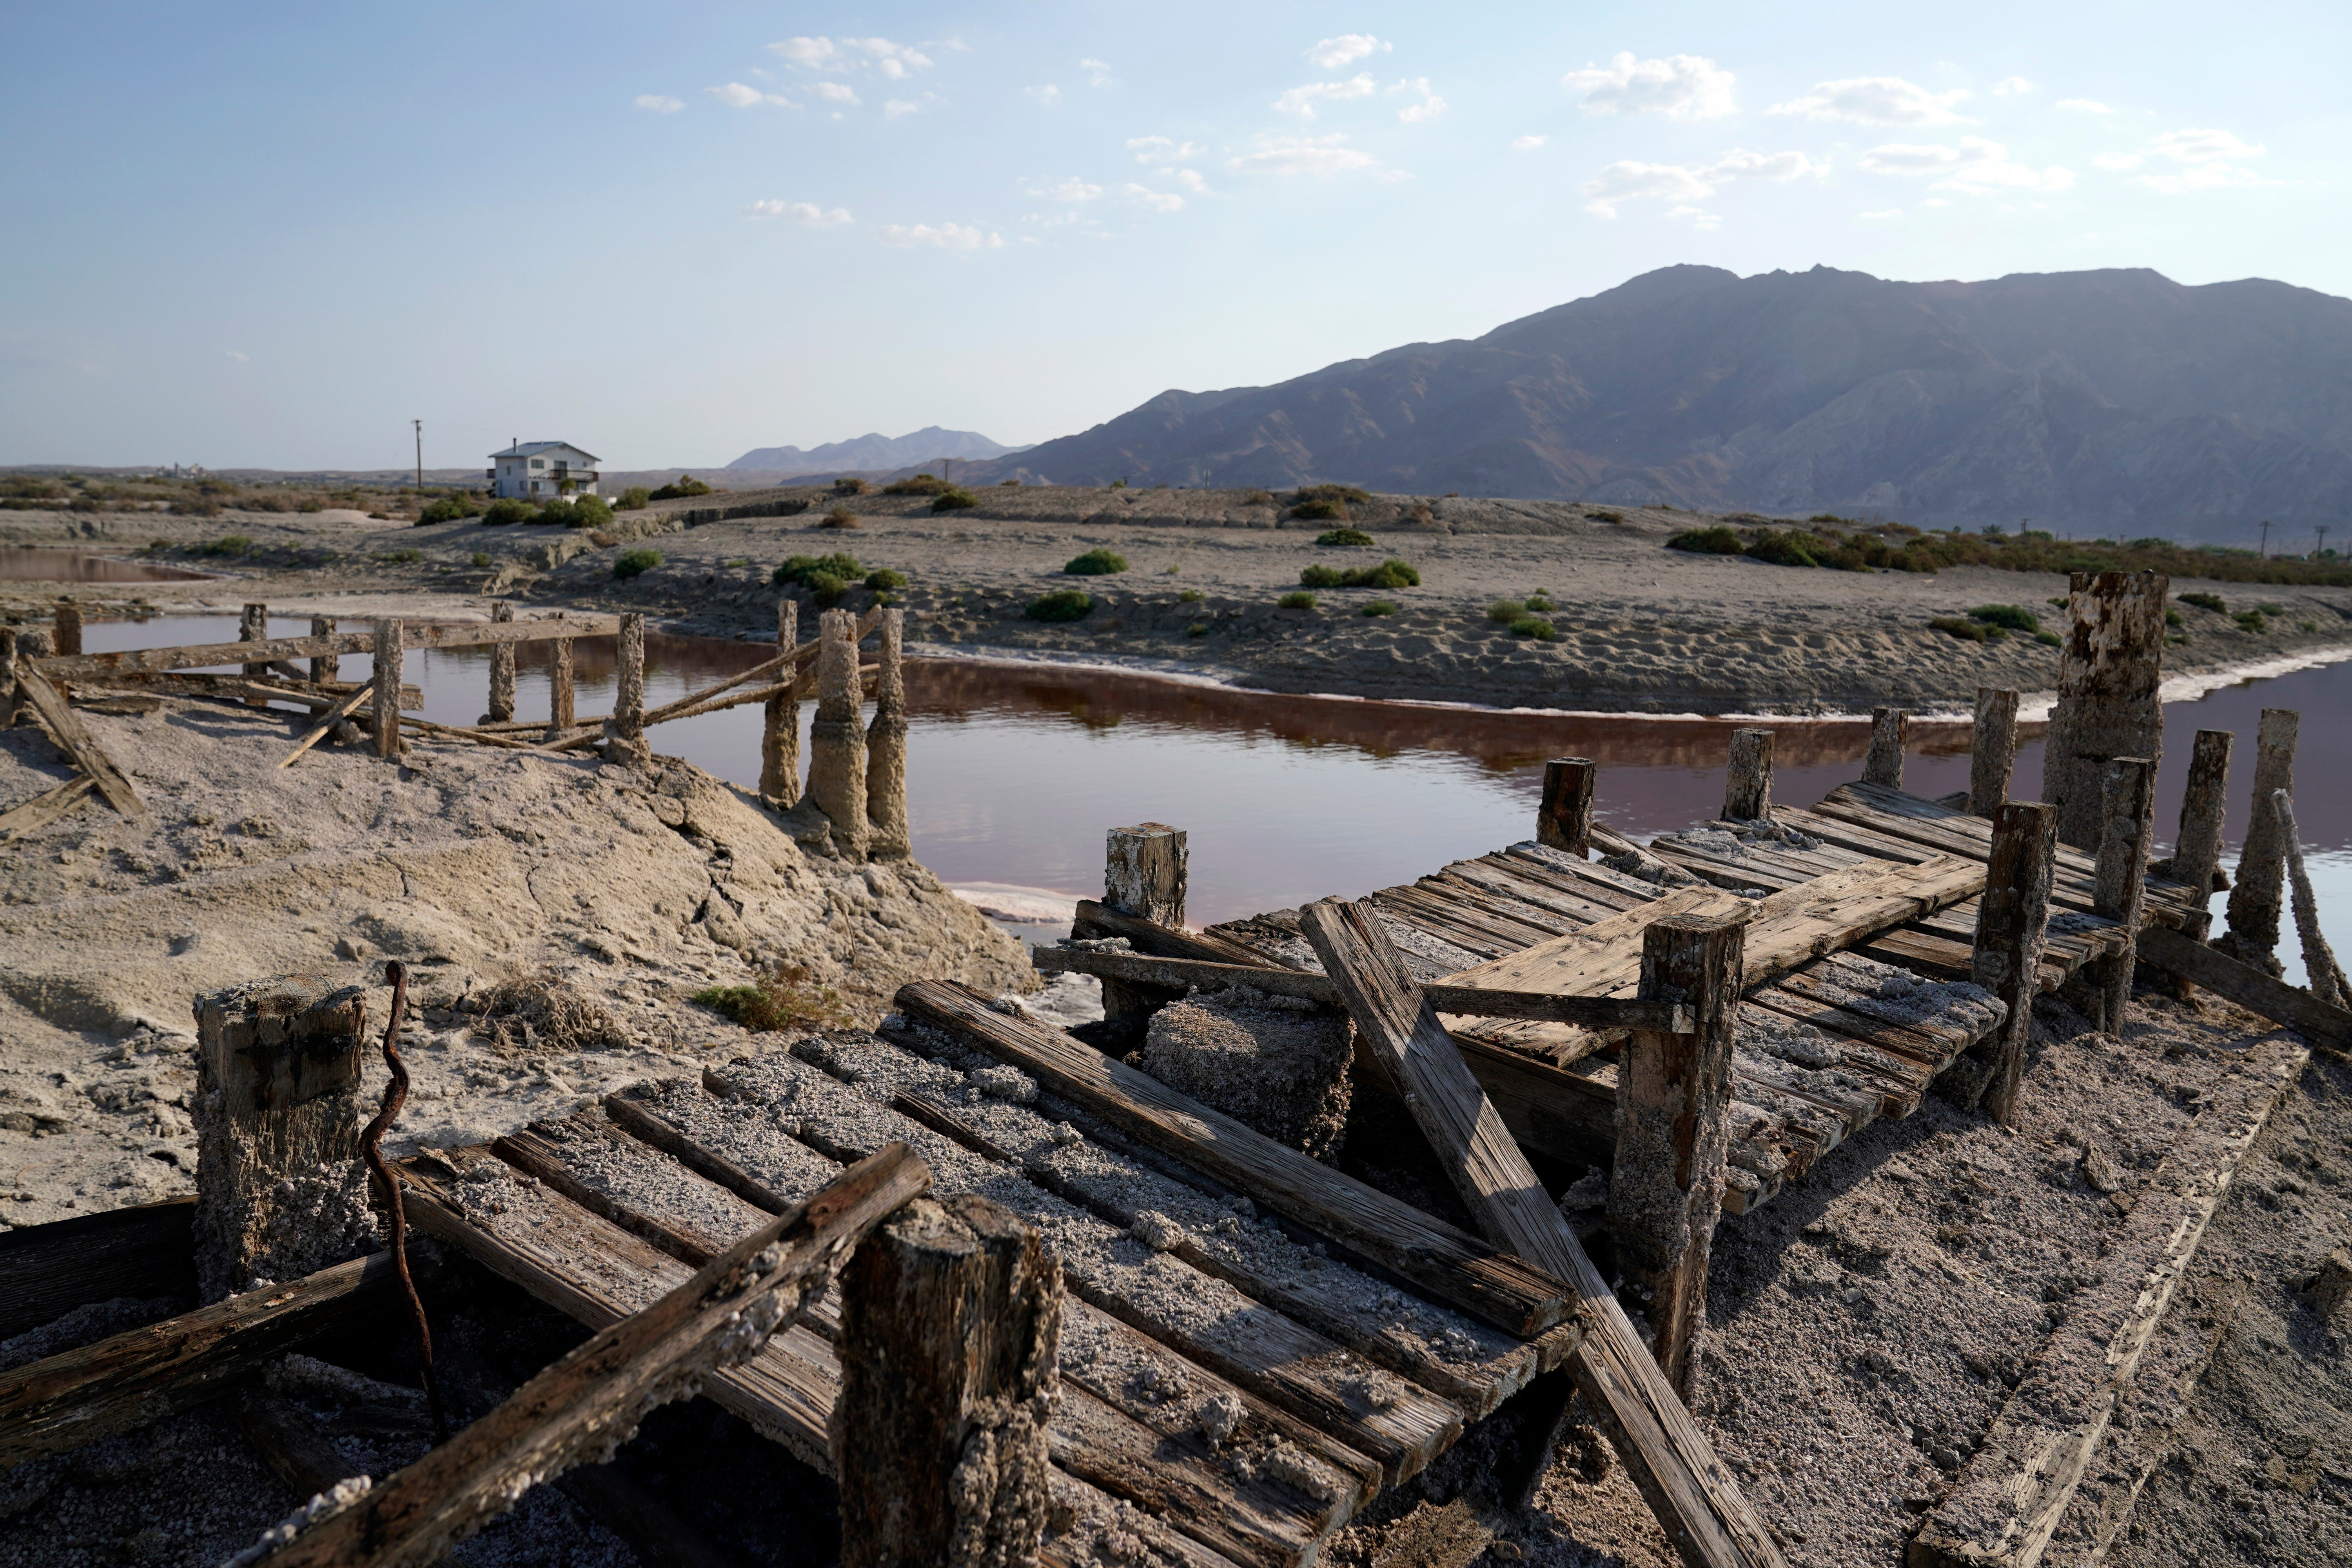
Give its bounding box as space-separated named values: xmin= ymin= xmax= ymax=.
xmin=828 ymin=1194 xmax=1061 ymax=1568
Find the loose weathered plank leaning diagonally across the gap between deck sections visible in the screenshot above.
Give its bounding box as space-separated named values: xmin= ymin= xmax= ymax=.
xmin=1298 ymin=900 xmax=1780 ymax=1568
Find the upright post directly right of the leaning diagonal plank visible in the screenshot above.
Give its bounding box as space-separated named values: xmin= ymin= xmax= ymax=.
xmin=1609 ymin=915 xmax=1748 ymax=1399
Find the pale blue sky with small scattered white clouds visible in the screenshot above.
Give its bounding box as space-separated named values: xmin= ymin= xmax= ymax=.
xmin=0 ymin=0 xmax=2352 ymax=468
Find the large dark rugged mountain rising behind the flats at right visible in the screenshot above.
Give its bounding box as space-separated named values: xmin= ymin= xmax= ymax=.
xmin=971 ymin=266 xmax=2352 ymax=536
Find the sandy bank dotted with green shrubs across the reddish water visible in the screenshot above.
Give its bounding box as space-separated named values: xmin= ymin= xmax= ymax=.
xmin=0 ymin=489 xmax=2352 ymax=712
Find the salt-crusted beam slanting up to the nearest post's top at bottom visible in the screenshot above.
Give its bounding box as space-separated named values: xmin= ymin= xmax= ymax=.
xmin=243 ymin=1143 xmax=931 ymax=1568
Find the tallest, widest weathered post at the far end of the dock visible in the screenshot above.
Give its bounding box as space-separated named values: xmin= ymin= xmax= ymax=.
xmin=2042 ymin=571 xmax=2171 ymax=849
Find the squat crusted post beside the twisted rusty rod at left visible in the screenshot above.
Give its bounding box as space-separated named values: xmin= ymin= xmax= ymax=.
xmin=191 ymin=976 xmax=376 ymax=1302
